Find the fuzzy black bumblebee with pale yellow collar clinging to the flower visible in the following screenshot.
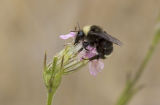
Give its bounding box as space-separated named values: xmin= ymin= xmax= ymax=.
xmin=74 ymin=25 xmax=122 ymax=61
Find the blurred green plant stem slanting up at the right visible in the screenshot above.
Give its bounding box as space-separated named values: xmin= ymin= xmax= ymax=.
xmin=116 ymin=20 xmax=160 ymax=105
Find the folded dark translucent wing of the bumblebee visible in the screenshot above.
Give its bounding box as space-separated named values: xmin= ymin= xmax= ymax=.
xmin=91 ymin=32 xmax=122 ymax=46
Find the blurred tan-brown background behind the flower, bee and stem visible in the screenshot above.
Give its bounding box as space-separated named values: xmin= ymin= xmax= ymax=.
xmin=0 ymin=0 xmax=160 ymax=105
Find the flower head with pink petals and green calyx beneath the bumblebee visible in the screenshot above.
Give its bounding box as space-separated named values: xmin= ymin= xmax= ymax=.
xmin=43 ymin=32 xmax=107 ymax=97
